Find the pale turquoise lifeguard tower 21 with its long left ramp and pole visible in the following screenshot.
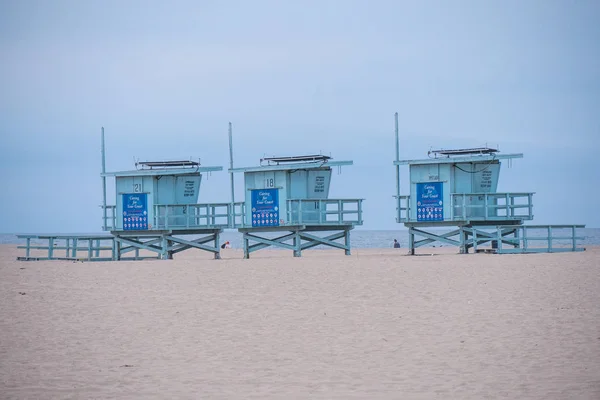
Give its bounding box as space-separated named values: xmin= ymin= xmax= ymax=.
xmin=18 ymin=128 xmax=244 ymax=261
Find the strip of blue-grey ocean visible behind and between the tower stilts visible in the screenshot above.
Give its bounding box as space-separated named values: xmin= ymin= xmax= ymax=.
xmin=0 ymin=228 xmax=600 ymax=249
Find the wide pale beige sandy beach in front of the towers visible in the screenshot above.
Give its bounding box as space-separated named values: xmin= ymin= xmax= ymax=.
xmin=0 ymin=245 xmax=600 ymax=400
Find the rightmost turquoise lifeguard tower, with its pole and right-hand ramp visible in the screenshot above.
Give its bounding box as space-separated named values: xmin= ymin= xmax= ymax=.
xmin=394 ymin=113 xmax=585 ymax=255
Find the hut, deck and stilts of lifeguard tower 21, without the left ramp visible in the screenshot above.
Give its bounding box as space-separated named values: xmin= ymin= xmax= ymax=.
xmin=101 ymin=128 xmax=243 ymax=260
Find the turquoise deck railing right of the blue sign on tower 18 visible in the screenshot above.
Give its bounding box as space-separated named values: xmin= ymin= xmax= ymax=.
xmin=287 ymin=199 xmax=363 ymax=225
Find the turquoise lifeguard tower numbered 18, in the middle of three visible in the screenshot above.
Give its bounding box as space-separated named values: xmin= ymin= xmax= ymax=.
xmin=229 ymin=151 xmax=362 ymax=258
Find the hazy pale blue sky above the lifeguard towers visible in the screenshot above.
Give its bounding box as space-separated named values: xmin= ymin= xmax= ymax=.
xmin=0 ymin=0 xmax=600 ymax=233
